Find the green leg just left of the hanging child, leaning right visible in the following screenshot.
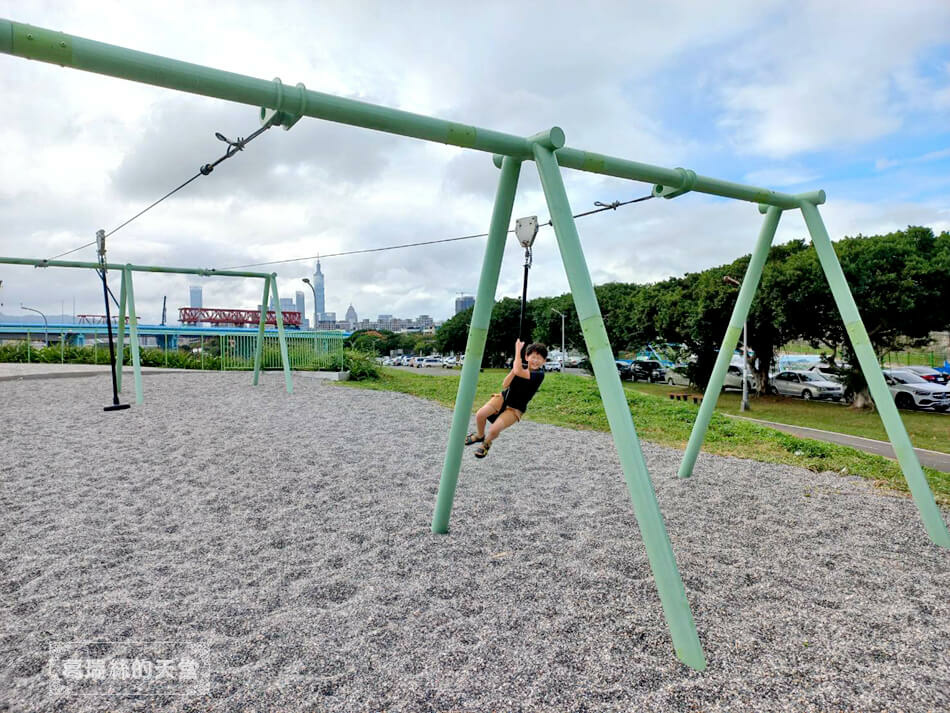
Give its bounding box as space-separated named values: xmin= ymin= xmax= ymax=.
xmin=432 ymin=158 xmax=521 ymax=534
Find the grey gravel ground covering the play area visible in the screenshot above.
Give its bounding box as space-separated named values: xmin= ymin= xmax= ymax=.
xmin=0 ymin=374 xmax=950 ymax=713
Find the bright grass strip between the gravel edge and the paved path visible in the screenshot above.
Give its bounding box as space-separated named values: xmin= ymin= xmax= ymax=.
xmin=340 ymin=369 xmax=950 ymax=505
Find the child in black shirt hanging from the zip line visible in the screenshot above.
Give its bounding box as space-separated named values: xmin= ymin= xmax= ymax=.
xmin=465 ymin=339 xmax=548 ymax=458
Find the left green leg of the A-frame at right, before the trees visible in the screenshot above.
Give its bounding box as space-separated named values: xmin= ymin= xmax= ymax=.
xmin=679 ymin=206 xmax=782 ymax=478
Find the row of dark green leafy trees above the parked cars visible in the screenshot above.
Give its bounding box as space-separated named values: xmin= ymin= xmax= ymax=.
xmin=437 ymin=226 xmax=950 ymax=387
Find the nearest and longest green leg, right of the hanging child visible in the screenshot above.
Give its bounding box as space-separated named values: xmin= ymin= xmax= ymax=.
xmin=534 ymin=127 xmax=706 ymax=671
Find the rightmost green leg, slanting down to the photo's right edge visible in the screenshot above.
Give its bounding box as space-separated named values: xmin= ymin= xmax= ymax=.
xmin=801 ymin=201 xmax=950 ymax=547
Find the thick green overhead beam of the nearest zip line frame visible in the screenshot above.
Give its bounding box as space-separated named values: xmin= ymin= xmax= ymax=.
xmin=0 ymin=19 xmax=824 ymax=209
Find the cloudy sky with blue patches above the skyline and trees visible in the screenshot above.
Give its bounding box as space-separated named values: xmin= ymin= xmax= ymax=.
xmin=0 ymin=0 xmax=950 ymax=322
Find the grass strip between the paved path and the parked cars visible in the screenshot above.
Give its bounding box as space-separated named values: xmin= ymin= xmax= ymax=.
xmin=629 ymin=382 xmax=950 ymax=453
